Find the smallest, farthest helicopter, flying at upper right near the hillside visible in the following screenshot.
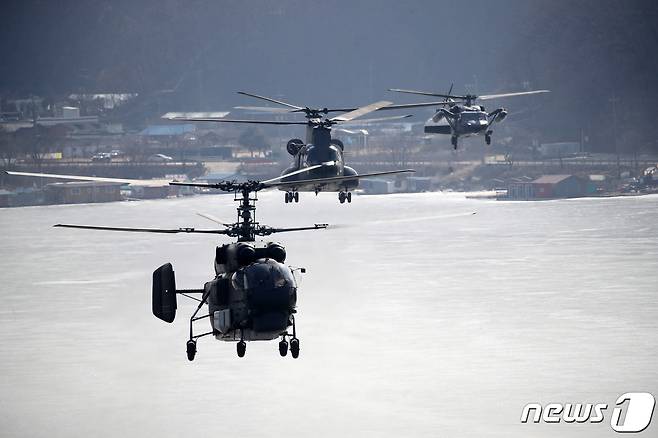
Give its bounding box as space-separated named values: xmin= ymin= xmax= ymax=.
xmin=389 ymin=86 xmax=550 ymax=150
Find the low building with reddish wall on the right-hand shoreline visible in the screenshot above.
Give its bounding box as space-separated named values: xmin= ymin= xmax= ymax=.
xmin=506 ymin=175 xmax=587 ymax=200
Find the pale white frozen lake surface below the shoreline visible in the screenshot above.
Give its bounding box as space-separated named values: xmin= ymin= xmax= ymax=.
xmin=0 ymin=193 xmax=658 ymax=438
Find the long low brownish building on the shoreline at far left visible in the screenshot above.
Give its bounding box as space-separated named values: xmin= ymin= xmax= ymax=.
xmin=45 ymin=181 xmax=124 ymax=204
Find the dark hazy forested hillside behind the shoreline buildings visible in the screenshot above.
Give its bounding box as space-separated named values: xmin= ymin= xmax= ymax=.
xmin=0 ymin=0 xmax=658 ymax=150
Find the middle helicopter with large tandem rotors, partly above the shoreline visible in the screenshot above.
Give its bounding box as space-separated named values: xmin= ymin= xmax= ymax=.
xmin=162 ymin=91 xmax=441 ymax=204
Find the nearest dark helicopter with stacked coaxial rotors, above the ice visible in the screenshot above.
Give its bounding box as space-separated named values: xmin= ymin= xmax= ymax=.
xmin=55 ymin=181 xmax=328 ymax=361
